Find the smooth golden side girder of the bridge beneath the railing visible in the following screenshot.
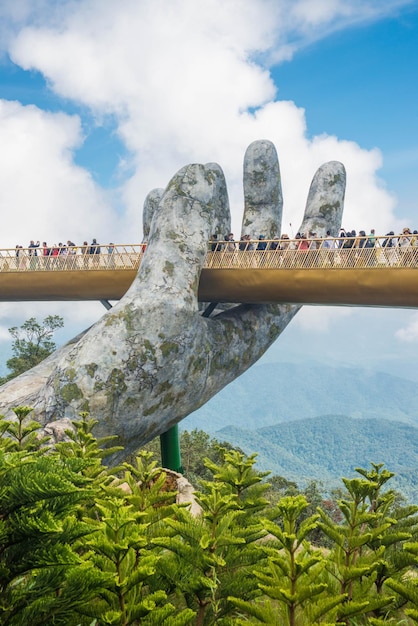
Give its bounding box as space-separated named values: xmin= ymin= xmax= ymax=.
xmin=0 ymin=267 xmax=418 ymax=308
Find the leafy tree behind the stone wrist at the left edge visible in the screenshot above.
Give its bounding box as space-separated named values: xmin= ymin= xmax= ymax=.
xmin=0 ymin=315 xmax=64 ymax=384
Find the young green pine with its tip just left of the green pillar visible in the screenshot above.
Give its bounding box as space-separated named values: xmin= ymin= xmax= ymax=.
xmin=79 ymin=452 xmax=194 ymax=626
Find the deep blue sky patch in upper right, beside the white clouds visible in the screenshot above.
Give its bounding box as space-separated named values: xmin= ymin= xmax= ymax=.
xmin=272 ymin=2 xmax=418 ymax=221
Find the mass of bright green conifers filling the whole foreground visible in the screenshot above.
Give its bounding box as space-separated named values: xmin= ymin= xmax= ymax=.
xmin=0 ymin=407 xmax=418 ymax=626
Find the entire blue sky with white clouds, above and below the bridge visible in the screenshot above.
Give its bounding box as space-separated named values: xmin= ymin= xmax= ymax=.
xmin=0 ymin=0 xmax=418 ymax=380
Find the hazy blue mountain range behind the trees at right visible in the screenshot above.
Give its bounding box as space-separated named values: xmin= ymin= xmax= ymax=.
xmin=181 ymin=363 xmax=418 ymax=503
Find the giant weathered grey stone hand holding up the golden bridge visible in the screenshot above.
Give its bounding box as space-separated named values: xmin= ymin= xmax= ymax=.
xmin=0 ymin=141 xmax=345 ymax=455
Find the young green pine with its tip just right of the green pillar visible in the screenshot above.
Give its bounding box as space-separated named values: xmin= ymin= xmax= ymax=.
xmin=155 ymin=451 xmax=267 ymax=626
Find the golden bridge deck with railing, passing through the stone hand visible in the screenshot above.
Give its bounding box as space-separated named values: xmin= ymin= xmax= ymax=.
xmin=0 ymin=236 xmax=418 ymax=308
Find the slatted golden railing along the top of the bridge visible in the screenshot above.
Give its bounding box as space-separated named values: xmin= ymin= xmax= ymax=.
xmin=0 ymin=235 xmax=418 ymax=272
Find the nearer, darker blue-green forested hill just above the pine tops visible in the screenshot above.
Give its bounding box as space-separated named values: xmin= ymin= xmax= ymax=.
xmin=216 ymin=415 xmax=418 ymax=502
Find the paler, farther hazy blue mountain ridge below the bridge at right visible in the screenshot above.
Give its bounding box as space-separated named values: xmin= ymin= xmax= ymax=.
xmin=181 ymin=363 xmax=418 ymax=433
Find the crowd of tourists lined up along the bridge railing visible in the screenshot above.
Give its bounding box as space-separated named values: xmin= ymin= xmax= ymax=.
xmin=1 ymin=227 xmax=418 ymax=269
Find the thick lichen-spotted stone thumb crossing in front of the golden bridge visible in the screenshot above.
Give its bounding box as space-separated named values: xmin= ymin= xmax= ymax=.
xmin=129 ymin=164 xmax=229 ymax=310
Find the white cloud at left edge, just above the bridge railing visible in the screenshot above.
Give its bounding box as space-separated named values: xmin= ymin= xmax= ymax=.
xmin=0 ymin=100 xmax=122 ymax=247
